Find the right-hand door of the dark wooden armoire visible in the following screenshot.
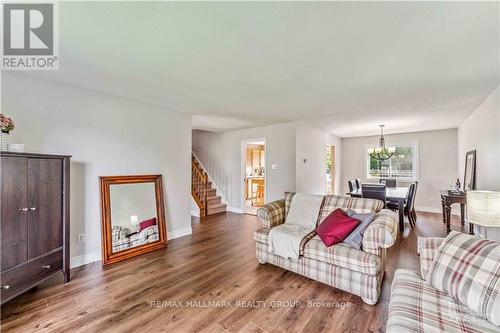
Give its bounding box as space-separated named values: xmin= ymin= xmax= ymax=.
xmin=28 ymin=158 xmax=63 ymax=258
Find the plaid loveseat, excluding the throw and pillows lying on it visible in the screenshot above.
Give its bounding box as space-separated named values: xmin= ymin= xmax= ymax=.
xmin=254 ymin=193 xmax=398 ymax=304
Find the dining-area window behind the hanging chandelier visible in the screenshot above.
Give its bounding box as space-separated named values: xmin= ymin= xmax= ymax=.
xmin=365 ymin=142 xmax=418 ymax=181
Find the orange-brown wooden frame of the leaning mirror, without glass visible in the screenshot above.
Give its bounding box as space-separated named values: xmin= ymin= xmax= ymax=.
xmin=99 ymin=175 xmax=167 ymax=266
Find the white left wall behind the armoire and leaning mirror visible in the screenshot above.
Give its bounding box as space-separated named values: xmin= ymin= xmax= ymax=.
xmin=2 ymin=72 xmax=191 ymax=265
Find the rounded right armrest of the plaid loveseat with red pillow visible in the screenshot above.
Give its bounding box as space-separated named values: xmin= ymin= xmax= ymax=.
xmin=363 ymin=209 xmax=398 ymax=256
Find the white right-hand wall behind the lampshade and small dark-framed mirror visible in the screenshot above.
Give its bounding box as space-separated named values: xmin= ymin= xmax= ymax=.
xmin=458 ymin=87 xmax=500 ymax=240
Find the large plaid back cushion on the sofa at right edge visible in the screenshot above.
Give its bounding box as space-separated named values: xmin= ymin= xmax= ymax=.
xmin=427 ymin=231 xmax=500 ymax=326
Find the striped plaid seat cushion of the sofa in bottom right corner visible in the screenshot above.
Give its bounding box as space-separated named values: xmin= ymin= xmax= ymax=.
xmin=386 ymin=269 xmax=498 ymax=333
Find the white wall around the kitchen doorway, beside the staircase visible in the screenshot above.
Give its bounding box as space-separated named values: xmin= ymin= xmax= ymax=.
xmin=193 ymin=123 xmax=295 ymax=212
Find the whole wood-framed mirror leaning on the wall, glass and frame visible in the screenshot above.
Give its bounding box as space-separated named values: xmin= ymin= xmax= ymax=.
xmin=100 ymin=175 xmax=167 ymax=265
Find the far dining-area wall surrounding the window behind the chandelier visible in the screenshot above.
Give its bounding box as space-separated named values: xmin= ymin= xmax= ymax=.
xmin=342 ymin=129 xmax=458 ymax=212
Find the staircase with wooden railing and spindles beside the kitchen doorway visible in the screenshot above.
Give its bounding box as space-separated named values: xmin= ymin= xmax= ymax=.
xmin=191 ymin=155 xmax=226 ymax=217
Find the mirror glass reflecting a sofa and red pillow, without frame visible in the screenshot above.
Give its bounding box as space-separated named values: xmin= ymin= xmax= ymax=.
xmin=109 ymin=182 xmax=159 ymax=253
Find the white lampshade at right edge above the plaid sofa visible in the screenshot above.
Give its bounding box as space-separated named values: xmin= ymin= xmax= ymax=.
xmin=467 ymin=190 xmax=500 ymax=230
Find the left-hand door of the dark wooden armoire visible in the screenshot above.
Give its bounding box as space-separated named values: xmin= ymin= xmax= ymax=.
xmin=0 ymin=157 xmax=29 ymax=271
